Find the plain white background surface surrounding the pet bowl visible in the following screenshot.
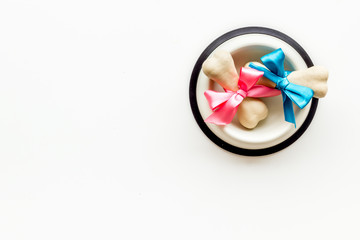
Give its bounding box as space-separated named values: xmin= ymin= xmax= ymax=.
xmin=0 ymin=0 xmax=360 ymax=240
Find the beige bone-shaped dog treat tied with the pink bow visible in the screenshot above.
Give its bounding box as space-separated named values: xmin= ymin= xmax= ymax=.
xmin=202 ymin=50 xmax=268 ymax=129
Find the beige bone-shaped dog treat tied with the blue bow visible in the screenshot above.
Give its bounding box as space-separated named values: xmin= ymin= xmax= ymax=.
xmin=245 ymin=62 xmax=329 ymax=98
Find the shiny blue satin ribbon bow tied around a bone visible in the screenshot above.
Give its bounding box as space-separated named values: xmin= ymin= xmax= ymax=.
xmin=249 ymin=48 xmax=314 ymax=127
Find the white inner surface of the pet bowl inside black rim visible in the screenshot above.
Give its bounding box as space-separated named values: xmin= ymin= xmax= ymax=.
xmin=196 ymin=34 xmax=311 ymax=149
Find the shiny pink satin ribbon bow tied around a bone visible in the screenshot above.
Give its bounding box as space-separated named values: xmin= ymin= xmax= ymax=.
xmin=204 ymin=67 xmax=281 ymax=125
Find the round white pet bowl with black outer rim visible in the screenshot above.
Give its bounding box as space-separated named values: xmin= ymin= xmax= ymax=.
xmin=189 ymin=27 xmax=318 ymax=156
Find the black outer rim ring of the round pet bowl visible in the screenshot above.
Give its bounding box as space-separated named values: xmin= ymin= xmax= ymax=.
xmin=189 ymin=27 xmax=319 ymax=156
